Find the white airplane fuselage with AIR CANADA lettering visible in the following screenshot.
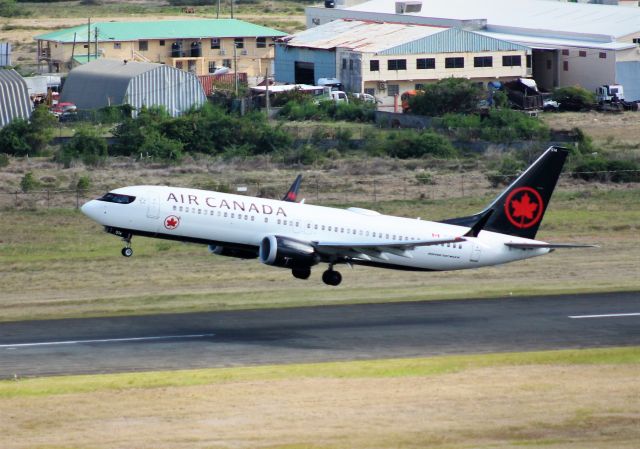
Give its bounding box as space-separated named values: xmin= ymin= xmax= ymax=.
xmin=82 ymin=186 xmax=550 ymax=271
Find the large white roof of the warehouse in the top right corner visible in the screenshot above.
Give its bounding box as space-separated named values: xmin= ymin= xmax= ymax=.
xmin=343 ymin=0 xmax=640 ymax=40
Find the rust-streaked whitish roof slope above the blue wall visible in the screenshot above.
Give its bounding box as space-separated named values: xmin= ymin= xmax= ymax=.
xmin=284 ymin=20 xmax=443 ymax=52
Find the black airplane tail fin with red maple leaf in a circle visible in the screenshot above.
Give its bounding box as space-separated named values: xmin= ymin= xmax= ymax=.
xmin=443 ymin=147 xmax=568 ymax=239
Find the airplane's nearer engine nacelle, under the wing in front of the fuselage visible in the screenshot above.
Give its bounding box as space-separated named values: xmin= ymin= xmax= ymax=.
xmin=258 ymin=235 xmax=319 ymax=268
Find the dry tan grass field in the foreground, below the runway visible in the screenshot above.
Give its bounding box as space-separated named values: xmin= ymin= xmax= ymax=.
xmin=0 ymin=348 xmax=640 ymax=449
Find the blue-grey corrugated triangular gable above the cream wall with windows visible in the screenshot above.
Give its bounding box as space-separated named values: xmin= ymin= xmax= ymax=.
xmin=378 ymin=28 xmax=530 ymax=55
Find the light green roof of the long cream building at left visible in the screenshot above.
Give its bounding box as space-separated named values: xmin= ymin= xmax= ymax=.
xmin=36 ymin=19 xmax=287 ymax=43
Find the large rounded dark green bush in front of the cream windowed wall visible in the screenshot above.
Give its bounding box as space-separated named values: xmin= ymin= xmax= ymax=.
xmin=409 ymin=78 xmax=483 ymax=117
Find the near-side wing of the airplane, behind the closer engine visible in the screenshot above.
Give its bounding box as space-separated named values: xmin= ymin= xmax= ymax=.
xmin=312 ymin=237 xmax=467 ymax=260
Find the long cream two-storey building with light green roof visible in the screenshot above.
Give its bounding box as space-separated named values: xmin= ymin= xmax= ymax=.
xmin=36 ymin=19 xmax=285 ymax=77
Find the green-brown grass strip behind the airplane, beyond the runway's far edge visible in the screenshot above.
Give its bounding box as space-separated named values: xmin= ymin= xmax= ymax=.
xmin=0 ymin=189 xmax=640 ymax=321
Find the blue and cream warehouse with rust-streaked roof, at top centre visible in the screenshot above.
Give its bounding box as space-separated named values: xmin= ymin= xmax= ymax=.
xmin=276 ymin=20 xmax=531 ymax=105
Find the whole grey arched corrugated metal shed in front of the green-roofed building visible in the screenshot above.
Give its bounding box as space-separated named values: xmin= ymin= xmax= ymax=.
xmin=60 ymin=59 xmax=206 ymax=117
